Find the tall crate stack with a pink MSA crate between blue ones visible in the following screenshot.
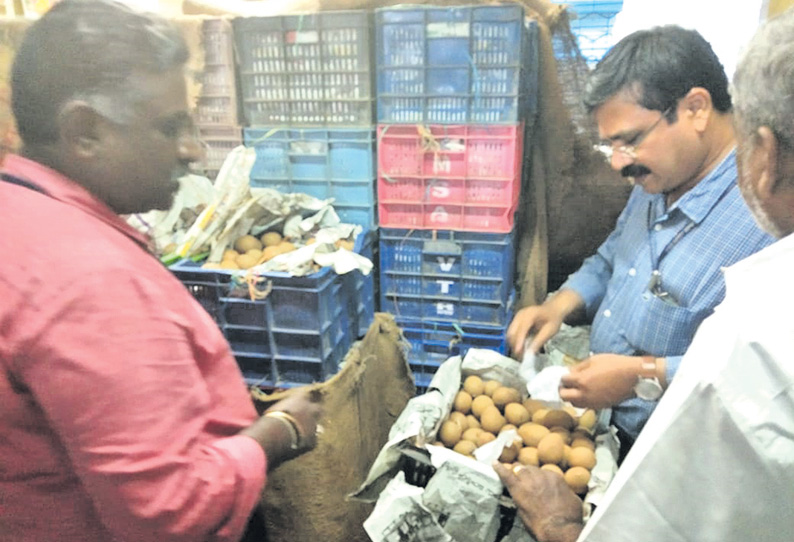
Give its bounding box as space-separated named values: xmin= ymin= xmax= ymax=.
xmin=375 ymin=4 xmax=537 ymax=392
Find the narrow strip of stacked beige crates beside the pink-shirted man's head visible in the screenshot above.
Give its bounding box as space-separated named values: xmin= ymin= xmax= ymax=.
xmin=194 ymin=19 xmax=242 ymax=180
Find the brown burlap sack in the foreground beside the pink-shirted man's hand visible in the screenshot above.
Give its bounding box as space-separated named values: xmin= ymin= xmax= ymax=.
xmin=256 ymin=313 xmax=415 ymax=542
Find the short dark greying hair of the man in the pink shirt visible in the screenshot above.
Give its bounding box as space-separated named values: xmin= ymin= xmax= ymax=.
xmin=11 ymin=0 xmax=189 ymax=144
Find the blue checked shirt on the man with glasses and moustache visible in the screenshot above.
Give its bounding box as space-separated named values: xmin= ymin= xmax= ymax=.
xmin=561 ymin=151 xmax=774 ymax=438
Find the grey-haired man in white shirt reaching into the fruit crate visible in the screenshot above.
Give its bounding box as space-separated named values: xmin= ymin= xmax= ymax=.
xmin=496 ymin=10 xmax=794 ymax=542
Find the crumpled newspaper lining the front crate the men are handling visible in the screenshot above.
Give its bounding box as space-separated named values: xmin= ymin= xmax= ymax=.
xmin=351 ymin=348 xmax=617 ymax=542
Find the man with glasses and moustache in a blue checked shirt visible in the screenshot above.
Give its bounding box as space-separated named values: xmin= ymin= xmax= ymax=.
xmin=507 ymin=26 xmax=773 ymax=456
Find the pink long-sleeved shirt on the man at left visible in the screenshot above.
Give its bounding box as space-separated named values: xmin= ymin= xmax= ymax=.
xmin=0 ymin=156 xmax=266 ymax=542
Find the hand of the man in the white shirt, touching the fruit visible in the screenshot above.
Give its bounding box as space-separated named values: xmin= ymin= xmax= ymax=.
xmin=494 ymin=462 xmax=583 ymax=542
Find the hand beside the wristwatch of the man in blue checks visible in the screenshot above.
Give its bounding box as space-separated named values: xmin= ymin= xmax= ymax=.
xmin=560 ymin=354 xmax=642 ymax=409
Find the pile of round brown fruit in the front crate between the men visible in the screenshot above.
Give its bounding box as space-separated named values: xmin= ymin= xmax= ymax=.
xmin=438 ymin=375 xmax=596 ymax=495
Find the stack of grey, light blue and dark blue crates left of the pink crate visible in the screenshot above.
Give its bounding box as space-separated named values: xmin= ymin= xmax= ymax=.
xmin=183 ymin=11 xmax=377 ymax=387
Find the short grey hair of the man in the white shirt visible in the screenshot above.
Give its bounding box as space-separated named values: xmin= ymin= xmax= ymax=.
xmin=731 ymin=10 xmax=794 ymax=147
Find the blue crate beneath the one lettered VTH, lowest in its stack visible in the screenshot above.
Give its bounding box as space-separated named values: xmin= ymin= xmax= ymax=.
xmin=397 ymin=319 xmax=508 ymax=393
